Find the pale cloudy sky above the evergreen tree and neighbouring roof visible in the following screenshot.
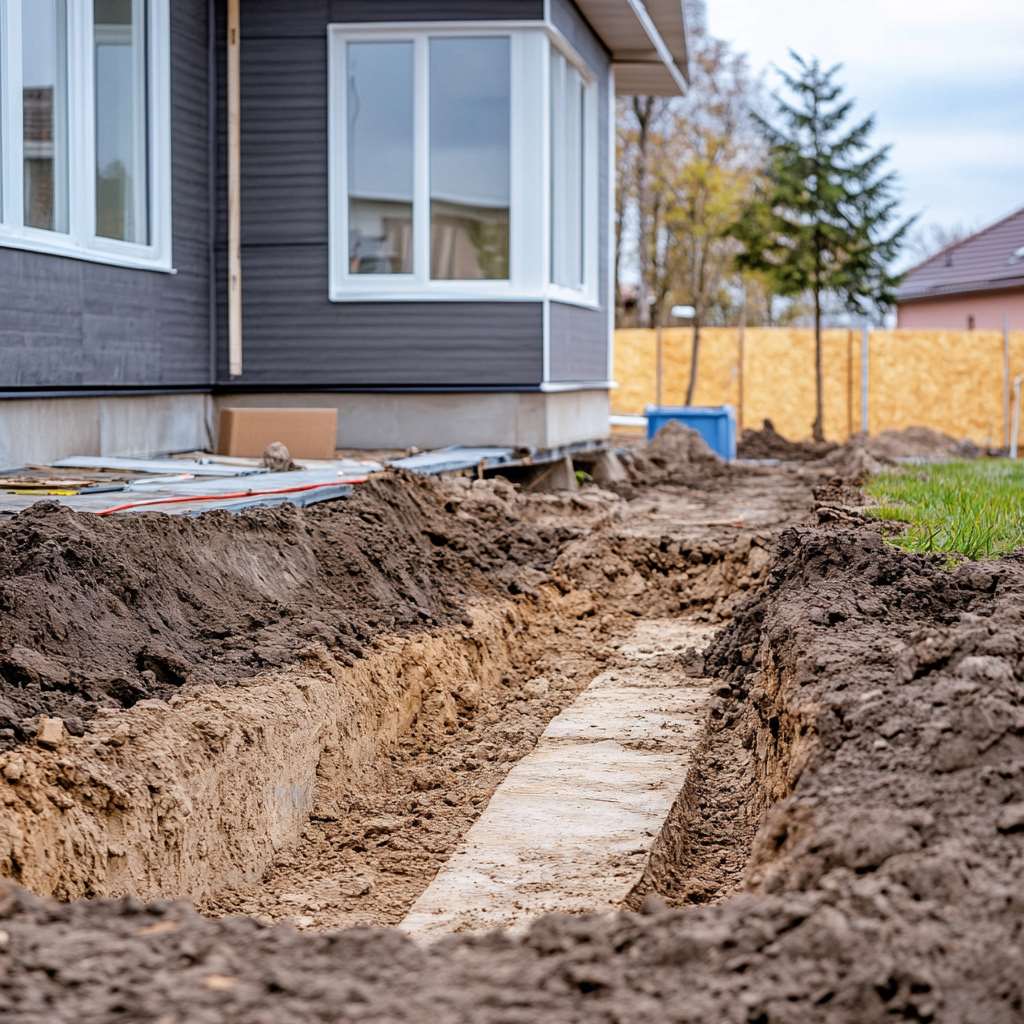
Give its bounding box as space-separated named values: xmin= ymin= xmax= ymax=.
xmin=708 ymin=0 xmax=1024 ymax=235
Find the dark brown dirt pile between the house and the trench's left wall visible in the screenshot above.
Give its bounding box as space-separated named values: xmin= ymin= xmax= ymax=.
xmin=0 ymin=475 xmax=561 ymax=750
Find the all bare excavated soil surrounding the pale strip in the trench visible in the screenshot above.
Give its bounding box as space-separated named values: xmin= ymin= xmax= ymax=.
xmin=0 ymin=421 xmax=1024 ymax=1024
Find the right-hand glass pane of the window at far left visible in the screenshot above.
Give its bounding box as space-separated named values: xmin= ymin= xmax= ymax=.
xmin=93 ymin=0 xmax=150 ymax=245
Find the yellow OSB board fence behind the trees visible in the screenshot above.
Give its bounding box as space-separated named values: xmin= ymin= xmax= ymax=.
xmin=612 ymin=328 xmax=1024 ymax=444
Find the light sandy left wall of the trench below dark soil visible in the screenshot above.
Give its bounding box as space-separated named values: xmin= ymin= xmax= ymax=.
xmin=0 ymin=602 xmax=529 ymax=900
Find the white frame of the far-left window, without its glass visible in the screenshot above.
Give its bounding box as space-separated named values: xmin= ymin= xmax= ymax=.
xmin=0 ymin=0 xmax=173 ymax=272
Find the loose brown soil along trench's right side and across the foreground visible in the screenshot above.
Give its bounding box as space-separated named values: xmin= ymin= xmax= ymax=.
xmin=0 ymin=516 xmax=1024 ymax=1024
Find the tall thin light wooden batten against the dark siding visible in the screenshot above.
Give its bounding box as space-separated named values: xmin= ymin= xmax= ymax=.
xmin=227 ymin=0 xmax=242 ymax=377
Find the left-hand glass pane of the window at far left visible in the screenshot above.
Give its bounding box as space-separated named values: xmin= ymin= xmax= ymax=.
xmin=22 ymin=0 xmax=68 ymax=232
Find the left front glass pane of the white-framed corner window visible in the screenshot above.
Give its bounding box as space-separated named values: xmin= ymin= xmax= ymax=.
xmin=346 ymin=42 xmax=415 ymax=273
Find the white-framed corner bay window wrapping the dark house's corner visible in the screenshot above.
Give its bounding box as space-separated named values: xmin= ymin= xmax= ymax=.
xmin=329 ymin=23 xmax=598 ymax=305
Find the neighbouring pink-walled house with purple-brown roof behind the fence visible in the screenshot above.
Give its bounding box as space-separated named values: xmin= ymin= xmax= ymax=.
xmin=896 ymin=208 xmax=1024 ymax=331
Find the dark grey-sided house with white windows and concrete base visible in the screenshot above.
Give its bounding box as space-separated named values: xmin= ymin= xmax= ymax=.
xmin=0 ymin=0 xmax=686 ymax=463
